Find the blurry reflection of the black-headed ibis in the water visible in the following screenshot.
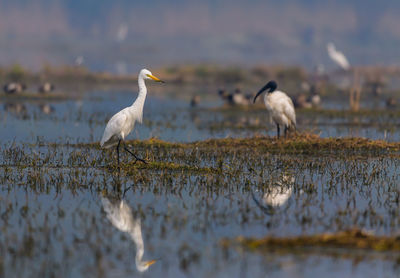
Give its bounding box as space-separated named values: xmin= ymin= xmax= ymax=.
xmin=252 ymin=175 xmax=295 ymax=214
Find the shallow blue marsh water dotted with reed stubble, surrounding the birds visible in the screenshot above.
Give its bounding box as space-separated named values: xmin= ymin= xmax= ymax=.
xmin=0 ymin=91 xmax=400 ymax=277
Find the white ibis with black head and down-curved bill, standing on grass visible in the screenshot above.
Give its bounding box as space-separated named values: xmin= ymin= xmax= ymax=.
xmin=253 ymin=81 xmax=296 ymax=138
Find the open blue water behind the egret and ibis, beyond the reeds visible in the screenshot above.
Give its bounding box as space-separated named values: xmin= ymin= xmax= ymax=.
xmin=0 ymin=91 xmax=400 ymax=142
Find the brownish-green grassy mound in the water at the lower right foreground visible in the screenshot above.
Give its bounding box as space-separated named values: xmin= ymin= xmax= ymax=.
xmin=222 ymin=229 xmax=400 ymax=251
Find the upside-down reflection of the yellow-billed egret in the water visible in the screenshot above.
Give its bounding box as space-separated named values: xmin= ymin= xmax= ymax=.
xmin=101 ymin=198 xmax=156 ymax=272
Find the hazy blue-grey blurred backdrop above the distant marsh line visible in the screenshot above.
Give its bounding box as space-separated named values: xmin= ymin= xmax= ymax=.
xmin=0 ymin=0 xmax=400 ymax=73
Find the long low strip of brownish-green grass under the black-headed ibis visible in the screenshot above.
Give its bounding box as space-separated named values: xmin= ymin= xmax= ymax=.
xmin=76 ymin=133 xmax=400 ymax=155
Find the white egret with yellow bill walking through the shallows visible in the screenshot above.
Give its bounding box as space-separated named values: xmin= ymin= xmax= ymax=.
xmin=100 ymin=69 xmax=164 ymax=165
